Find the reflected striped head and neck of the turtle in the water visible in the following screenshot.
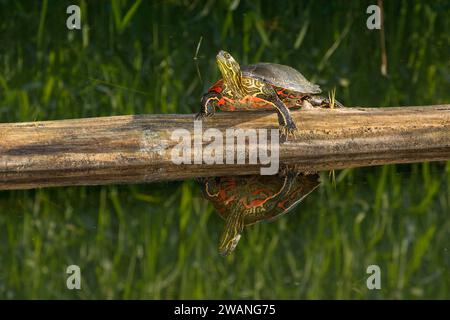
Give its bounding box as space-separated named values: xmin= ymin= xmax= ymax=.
xmin=219 ymin=210 xmax=244 ymax=256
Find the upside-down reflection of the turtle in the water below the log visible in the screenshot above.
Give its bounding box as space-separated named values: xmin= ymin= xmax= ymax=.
xmin=200 ymin=168 xmax=320 ymax=255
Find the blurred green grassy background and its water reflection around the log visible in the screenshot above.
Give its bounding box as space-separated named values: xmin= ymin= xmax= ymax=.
xmin=0 ymin=0 xmax=450 ymax=299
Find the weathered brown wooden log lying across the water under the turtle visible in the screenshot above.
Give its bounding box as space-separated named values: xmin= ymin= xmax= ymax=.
xmin=0 ymin=105 xmax=450 ymax=189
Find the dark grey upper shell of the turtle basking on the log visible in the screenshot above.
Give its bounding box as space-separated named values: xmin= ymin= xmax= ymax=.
xmin=241 ymin=63 xmax=322 ymax=94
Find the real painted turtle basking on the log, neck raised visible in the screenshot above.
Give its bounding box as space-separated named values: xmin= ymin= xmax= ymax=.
xmin=196 ymin=51 xmax=342 ymax=138
